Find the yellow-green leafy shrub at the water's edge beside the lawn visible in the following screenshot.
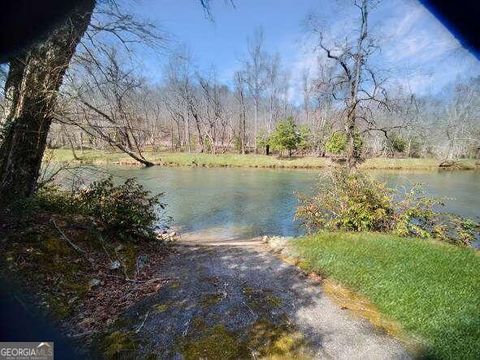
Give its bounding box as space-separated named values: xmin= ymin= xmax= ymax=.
xmin=296 ymin=168 xmax=479 ymax=244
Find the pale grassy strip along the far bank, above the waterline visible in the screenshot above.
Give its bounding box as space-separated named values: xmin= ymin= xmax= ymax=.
xmin=47 ymin=149 xmax=477 ymax=170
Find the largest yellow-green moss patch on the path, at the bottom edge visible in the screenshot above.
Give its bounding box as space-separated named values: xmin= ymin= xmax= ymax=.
xmin=178 ymin=286 xmax=309 ymax=359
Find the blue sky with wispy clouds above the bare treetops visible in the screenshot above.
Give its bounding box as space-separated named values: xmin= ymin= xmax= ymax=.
xmin=130 ymin=0 xmax=480 ymax=98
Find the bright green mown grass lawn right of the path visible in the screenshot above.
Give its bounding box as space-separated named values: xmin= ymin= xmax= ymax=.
xmin=293 ymin=233 xmax=480 ymax=359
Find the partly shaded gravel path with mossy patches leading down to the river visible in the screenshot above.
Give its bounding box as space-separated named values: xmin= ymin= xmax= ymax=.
xmin=112 ymin=239 xmax=409 ymax=359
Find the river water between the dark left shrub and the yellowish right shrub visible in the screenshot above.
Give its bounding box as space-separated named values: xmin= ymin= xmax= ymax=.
xmin=106 ymin=168 xmax=316 ymax=239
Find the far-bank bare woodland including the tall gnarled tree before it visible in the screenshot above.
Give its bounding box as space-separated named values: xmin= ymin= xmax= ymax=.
xmin=2 ymin=8 xmax=480 ymax=165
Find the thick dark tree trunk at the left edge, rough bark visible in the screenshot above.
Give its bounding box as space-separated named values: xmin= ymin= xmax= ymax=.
xmin=0 ymin=0 xmax=95 ymax=205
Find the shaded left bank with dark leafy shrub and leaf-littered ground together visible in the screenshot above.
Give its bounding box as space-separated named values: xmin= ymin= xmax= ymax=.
xmin=0 ymin=178 xmax=175 ymax=358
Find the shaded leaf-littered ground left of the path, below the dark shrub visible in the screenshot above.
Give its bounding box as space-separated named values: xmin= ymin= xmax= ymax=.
xmin=0 ymin=212 xmax=171 ymax=352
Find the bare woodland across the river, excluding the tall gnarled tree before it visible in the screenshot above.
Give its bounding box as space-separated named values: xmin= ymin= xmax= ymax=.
xmin=43 ymin=50 xmax=480 ymax=160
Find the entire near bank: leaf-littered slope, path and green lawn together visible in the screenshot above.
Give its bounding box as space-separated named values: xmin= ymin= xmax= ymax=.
xmin=2 ymin=208 xmax=480 ymax=359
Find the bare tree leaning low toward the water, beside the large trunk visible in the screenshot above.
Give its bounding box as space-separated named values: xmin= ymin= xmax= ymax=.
xmin=56 ymin=49 xmax=153 ymax=166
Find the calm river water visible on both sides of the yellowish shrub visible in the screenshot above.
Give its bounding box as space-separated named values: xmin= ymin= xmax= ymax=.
xmin=95 ymin=167 xmax=480 ymax=239
